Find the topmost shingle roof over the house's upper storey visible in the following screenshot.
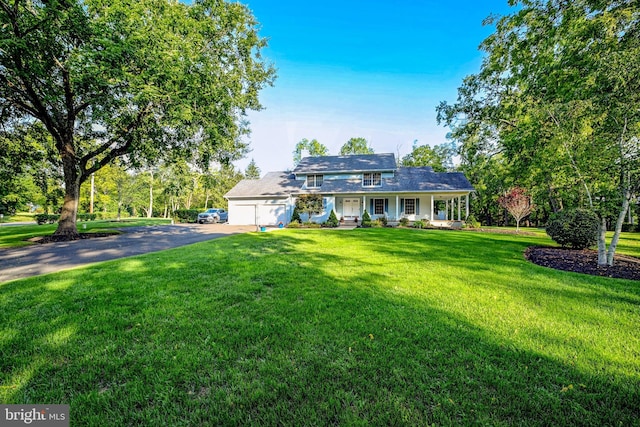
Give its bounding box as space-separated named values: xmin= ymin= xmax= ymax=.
xmin=293 ymin=153 xmax=397 ymax=174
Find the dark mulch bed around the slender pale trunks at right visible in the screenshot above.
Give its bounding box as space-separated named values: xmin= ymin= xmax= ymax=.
xmin=524 ymin=246 xmax=640 ymax=280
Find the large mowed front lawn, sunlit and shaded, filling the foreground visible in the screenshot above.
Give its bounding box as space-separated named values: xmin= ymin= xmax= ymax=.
xmin=0 ymin=229 xmax=640 ymax=426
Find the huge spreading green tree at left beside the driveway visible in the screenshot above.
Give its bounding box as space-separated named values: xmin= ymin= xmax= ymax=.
xmin=0 ymin=0 xmax=274 ymax=239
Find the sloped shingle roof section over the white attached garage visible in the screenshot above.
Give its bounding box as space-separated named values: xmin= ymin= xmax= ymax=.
xmin=224 ymin=172 xmax=304 ymax=198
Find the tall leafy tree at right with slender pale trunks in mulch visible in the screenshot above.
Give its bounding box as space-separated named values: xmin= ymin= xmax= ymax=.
xmin=439 ymin=0 xmax=640 ymax=265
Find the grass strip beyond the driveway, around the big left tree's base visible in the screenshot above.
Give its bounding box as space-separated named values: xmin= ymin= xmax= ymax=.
xmin=0 ymin=218 xmax=171 ymax=248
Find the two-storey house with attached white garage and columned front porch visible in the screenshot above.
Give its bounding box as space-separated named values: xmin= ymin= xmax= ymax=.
xmin=224 ymin=154 xmax=474 ymax=225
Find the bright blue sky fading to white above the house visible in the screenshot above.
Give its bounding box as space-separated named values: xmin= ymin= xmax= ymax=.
xmin=236 ymin=0 xmax=512 ymax=174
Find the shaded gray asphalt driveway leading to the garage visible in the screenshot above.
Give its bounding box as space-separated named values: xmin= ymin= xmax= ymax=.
xmin=0 ymin=224 xmax=256 ymax=283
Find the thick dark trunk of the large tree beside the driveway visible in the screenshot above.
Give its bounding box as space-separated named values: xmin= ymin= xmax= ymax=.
xmin=53 ymin=154 xmax=80 ymax=241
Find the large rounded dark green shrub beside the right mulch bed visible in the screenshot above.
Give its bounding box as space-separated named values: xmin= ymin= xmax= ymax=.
xmin=546 ymin=209 xmax=600 ymax=249
